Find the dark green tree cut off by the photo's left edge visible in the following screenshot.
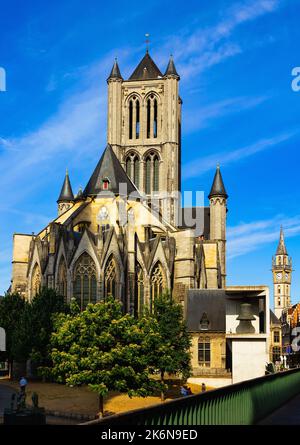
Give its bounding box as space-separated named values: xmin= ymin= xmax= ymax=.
xmin=0 ymin=294 xmax=27 ymax=373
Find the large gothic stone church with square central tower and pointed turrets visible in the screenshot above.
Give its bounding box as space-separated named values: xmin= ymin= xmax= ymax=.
xmin=11 ymin=51 xmax=227 ymax=314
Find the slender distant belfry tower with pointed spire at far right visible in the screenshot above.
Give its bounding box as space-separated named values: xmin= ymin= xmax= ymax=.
xmin=272 ymin=227 xmax=292 ymax=318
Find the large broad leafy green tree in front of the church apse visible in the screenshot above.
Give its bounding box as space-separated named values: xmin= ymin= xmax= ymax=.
xmin=45 ymin=298 xmax=159 ymax=416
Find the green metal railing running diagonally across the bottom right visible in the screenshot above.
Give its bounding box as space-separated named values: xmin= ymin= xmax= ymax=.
xmin=82 ymin=369 xmax=300 ymax=426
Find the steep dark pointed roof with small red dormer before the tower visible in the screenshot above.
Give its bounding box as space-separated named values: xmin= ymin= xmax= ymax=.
xmin=83 ymin=144 xmax=139 ymax=197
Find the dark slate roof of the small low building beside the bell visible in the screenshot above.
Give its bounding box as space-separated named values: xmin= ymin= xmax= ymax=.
xmin=186 ymin=289 xmax=226 ymax=334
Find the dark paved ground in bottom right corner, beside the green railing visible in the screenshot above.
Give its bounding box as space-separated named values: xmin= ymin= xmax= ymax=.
xmin=259 ymin=394 xmax=300 ymax=425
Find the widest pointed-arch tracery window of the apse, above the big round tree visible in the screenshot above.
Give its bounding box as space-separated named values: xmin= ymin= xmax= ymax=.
xmin=74 ymin=253 xmax=97 ymax=311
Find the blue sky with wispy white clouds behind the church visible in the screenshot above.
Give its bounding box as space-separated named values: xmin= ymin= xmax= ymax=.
xmin=0 ymin=0 xmax=300 ymax=302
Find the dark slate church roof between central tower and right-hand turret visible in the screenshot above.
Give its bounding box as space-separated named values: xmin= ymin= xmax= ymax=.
xmin=179 ymin=207 xmax=210 ymax=240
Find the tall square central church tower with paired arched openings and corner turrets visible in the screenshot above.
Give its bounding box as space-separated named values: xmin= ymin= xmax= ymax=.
xmin=107 ymin=51 xmax=181 ymax=222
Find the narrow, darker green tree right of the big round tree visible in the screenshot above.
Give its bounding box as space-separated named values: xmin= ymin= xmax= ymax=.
xmin=146 ymin=292 xmax=191 ymax=401
